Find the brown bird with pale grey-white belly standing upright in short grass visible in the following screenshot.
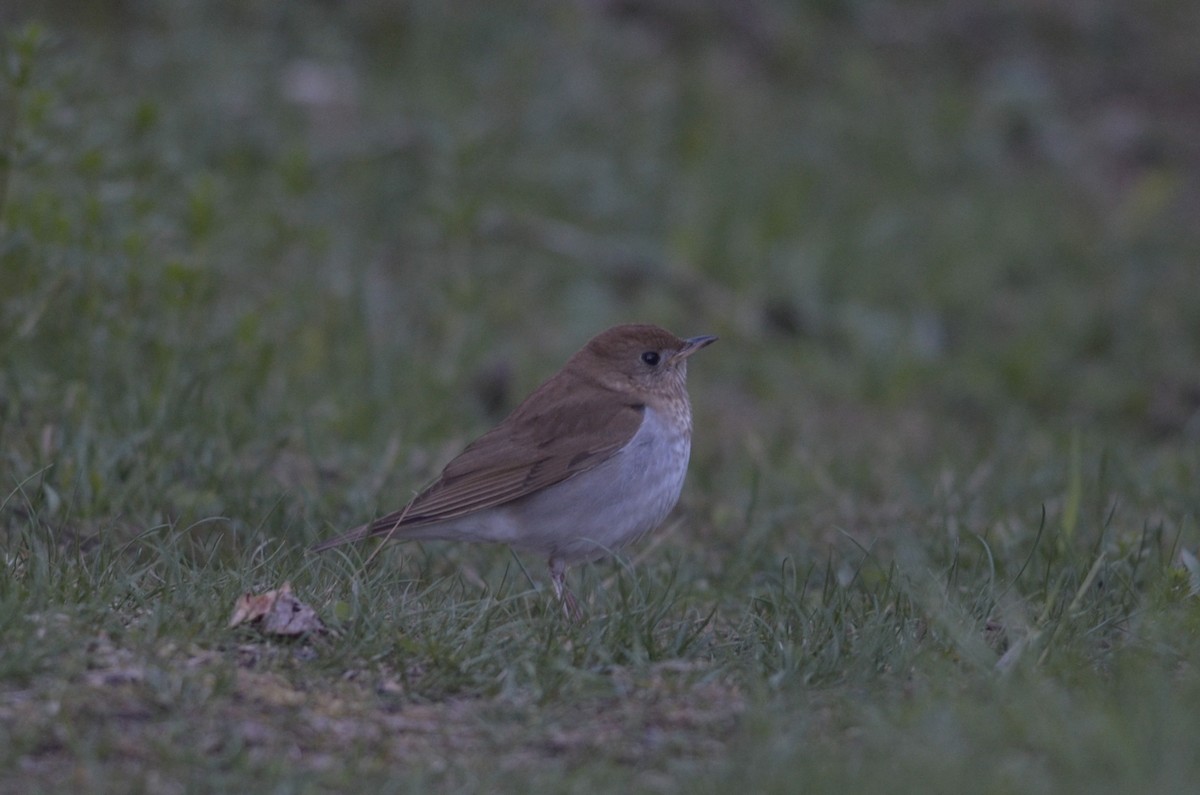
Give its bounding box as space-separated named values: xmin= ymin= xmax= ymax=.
xmin=312 ymin=325 xmax=716 ymax=616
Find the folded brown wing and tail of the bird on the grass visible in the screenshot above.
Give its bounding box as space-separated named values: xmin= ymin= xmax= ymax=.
xmin=313 ymin=390 xmax=644 ymax=551
